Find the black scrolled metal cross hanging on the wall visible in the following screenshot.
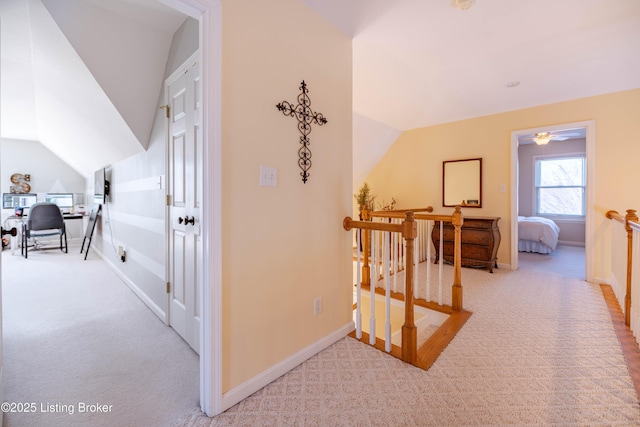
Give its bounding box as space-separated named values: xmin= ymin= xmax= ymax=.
xmin=276 ymin=80 xmax=327 ymax=184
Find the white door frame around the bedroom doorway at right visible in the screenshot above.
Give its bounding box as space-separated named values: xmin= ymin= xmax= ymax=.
xmin=511 ymin=120 xmax=596 ymax=282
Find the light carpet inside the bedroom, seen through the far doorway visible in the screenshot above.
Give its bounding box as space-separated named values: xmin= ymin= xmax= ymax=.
xmin=518 ymin=245 xmax=585 ymax=280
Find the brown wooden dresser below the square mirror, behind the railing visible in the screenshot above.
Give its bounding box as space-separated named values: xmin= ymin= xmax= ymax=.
xmin=431 ymin=217 xmax=500 ymax=273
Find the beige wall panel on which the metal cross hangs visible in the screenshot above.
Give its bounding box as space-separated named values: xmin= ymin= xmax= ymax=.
xmin=222 ymin=0 xmax=352 ymax=392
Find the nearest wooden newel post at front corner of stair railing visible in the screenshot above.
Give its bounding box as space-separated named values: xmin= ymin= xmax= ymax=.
xmin=402 ymin=212 xmax=418 ymax=364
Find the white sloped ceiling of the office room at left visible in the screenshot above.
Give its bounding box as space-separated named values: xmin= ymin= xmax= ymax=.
xmin=0 ymin=0 xmax=186 ymax=177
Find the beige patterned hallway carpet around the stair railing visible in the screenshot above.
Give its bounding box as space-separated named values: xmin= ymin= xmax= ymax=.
xmin=175 ymin=266 xmax=640 ymax=427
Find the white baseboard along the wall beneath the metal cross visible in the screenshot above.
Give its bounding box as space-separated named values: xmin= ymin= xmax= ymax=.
xmin=220 ymin=322 xmax=355 ymax=412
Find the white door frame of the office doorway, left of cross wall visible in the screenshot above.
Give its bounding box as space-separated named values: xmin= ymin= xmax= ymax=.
xmin=160 ymin=0 xmax=222 ymax=416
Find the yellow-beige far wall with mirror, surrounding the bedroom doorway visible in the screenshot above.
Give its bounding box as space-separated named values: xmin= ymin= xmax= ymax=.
xmin=367 ymin=89 xmax=640 ymax=279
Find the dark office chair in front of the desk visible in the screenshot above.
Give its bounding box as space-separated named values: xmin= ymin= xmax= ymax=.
xmin=21 ymin=203 xmax=67 ymax=258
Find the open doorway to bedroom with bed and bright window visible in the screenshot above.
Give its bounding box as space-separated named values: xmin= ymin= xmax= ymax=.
xmin=512 ymin=123 xmax=593 ymax=280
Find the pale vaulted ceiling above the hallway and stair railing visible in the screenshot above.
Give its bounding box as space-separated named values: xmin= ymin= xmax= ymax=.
xmin=303 ymin=0 xmax=640 ymax=186
